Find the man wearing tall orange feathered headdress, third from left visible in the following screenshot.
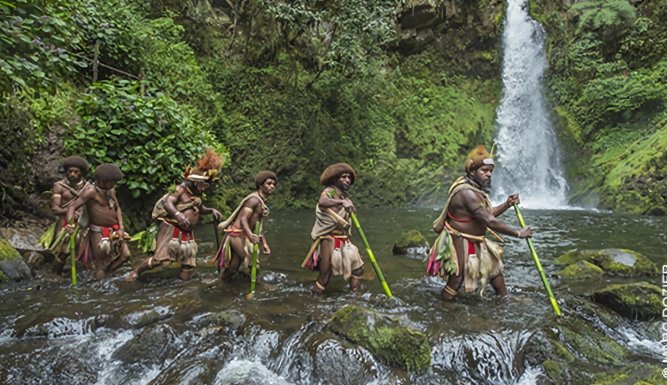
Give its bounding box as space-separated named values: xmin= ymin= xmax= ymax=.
xmin=129 ymin=149 xmax=222 ymax=281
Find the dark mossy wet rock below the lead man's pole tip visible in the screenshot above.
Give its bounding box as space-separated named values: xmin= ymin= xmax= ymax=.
xmin=523 ymin=318 xmax=630 ymax=384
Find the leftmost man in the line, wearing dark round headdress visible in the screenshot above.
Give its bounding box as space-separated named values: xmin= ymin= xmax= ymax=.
xmin=44 ymin=156 xmax=90 ymax=274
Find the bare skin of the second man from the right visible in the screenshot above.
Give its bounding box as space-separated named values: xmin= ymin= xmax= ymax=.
xmin=313 ymin=173 xmax=364 ymax=293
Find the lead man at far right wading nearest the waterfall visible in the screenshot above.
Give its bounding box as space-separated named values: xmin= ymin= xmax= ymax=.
xmin=426 ymin=146 xmax=532 ymax=301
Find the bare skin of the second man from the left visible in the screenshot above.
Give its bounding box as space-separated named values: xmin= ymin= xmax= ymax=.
xmin=67 ymin=179 xmax=130 ymax=280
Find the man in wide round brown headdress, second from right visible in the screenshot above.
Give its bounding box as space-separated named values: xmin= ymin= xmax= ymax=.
xmin=302 ymin=163 xmax=364 ymax=293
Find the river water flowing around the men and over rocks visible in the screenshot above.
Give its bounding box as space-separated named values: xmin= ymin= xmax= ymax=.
xmin=0 ymin=209 xmax=667 ymax=385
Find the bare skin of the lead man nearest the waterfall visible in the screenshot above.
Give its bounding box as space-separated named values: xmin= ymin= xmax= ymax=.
xmin=441 ymin=165 xmax=533 ymax=301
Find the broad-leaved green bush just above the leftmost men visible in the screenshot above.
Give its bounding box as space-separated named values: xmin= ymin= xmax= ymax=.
xmin=65 ymin=80 xmax=226 ymax=198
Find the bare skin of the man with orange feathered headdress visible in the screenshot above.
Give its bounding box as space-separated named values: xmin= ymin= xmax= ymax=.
xmin=128 ymin=181 xmax=222 ymax=281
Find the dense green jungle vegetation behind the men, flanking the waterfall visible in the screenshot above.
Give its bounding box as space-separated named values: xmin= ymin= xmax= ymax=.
xmin=0 ymin=0 xmax=667 ymax=224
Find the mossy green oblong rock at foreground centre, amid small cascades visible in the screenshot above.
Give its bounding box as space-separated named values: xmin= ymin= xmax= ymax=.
xmin=328 ymin=305 xmax=431 ymax=373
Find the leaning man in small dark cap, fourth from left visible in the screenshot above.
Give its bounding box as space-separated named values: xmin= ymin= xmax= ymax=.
xmin=215 ymin=171 xmax=277 ymax=282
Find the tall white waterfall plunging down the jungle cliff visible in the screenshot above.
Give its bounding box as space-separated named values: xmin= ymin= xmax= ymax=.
xmin=492 ymin=0 xmax=568 ymax=209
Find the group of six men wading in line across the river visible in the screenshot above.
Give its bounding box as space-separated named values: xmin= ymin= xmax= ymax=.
xmin=43 ymin=146 xmax=532 ymax=300
